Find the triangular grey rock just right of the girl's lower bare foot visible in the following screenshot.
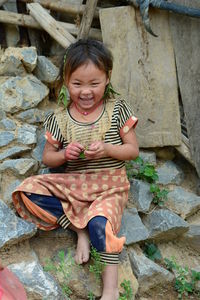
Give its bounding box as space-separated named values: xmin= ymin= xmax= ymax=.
xmin=129 ymin=245 xmax=174 ymax=292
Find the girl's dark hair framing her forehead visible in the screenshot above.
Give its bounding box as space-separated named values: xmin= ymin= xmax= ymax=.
xmin=60 ymin=39 xmax=113 ymax=81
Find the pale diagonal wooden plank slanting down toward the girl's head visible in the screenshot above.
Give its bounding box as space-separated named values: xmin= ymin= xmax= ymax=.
xmin=27 ymin=3 xmax=75 ymax=48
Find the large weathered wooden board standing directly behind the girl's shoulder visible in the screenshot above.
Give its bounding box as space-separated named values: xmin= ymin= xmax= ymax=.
xmin=100 ymin=6 xmax=181 ymax=148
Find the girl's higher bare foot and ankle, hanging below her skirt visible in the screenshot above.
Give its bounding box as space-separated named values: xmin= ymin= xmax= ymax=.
xmin=75 ymin=229 xmax=90 ymax=264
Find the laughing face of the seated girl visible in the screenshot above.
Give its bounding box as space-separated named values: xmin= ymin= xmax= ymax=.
xmin=66 ymin=61 xmax=109 ymax=111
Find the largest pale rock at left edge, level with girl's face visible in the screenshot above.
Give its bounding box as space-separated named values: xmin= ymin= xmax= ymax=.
xmin=0 ymin=75 xmax=49 ymax=113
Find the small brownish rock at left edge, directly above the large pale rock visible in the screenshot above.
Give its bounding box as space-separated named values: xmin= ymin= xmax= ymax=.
xmin=0 ymin=55 xmax=26 ymax=76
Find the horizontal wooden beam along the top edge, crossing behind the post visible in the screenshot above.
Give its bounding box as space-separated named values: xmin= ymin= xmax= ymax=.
xmin=21 ymin=0 xmax=99 ymax=18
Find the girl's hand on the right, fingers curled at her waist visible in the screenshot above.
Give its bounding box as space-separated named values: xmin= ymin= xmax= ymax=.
xmin=84 ymin=141 xmax=108 ymax=159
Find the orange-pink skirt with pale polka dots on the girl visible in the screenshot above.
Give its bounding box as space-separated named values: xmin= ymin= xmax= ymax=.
xmin=12 ymin=168 xmax=130 ymax=235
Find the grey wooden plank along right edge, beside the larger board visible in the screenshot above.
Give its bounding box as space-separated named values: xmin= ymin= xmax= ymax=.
xmin=170 ymin=0 xmax=200 ymax=177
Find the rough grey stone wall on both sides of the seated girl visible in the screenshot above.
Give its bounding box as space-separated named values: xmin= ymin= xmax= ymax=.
xmin=0 ymin=47 xmax=200 ymax=300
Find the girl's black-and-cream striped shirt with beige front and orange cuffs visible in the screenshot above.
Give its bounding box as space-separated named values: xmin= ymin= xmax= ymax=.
xmin=44 ymin=100 xmax=137 ymax=172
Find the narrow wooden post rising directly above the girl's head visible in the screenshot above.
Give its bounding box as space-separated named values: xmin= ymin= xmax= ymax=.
xmin=77 ymin=0 xmax=98 ymax=39
